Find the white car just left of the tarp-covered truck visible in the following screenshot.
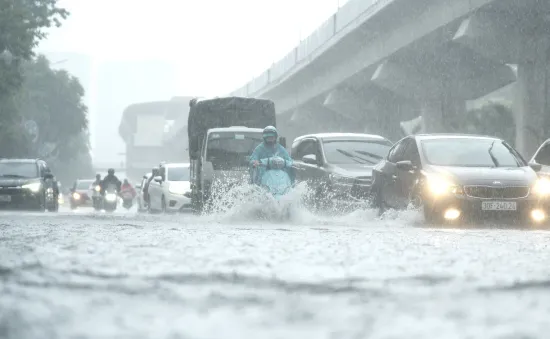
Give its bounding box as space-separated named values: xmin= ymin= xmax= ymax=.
xmin=149 ymin=163 xmax=191 ymax=212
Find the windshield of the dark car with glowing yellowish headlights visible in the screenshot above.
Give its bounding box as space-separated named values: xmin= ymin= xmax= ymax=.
xmin=421 ymin=138 xmax=524 ymax=167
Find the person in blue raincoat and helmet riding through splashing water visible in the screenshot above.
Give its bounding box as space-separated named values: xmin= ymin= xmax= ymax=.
xmin=250 ymin=126 xmax=296 ymax=185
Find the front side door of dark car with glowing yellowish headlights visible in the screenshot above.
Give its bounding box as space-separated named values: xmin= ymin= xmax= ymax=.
xmin=395 ymin=138 xmax=421 ymax=208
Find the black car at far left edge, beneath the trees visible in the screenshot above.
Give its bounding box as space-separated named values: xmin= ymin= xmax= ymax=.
xmin=0 ymin=159 xmax=59 ymax=211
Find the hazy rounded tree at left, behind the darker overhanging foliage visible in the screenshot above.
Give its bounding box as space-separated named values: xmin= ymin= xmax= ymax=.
xmin=14 ymin=55 xmax=92 ymax=182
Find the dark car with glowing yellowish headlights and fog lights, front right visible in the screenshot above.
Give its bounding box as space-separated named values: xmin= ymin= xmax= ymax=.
xmin=373 ymin=134 xmax=550 ymax=223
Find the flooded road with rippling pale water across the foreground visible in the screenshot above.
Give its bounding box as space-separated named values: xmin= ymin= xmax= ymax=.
xmin=0 ymin=207 xmax=550 ymax=339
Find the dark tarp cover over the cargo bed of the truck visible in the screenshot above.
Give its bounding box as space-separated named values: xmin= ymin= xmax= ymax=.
xmin=187 ymin=97 xmax=276 ymax=156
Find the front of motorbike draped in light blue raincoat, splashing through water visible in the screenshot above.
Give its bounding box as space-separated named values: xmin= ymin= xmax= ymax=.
xmin=254 ymin=156 xmax=292 ymax=219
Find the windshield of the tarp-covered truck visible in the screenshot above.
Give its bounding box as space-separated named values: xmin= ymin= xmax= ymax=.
xmin=206 ymin=132 xmax=262 ymax=170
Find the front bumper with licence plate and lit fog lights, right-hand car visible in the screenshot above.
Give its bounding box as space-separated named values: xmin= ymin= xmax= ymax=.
xmin=424 ymin=195 xmax=550 ymax=223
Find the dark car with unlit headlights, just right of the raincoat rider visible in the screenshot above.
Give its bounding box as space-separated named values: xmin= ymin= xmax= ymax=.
xmin=290 ymin=133 xmax=393 ymax=206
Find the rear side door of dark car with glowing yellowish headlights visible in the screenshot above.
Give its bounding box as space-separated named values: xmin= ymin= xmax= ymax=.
xmin=380 ymin=138 xmax=409 ymax=208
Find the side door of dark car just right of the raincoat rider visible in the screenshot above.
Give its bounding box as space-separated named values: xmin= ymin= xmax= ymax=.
xmin=292 ymin=138 xmax=322 ymax=186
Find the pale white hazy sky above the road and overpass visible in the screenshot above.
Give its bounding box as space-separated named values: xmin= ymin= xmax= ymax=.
xmin=40 ymin=0 xmax=346 ymax=97
